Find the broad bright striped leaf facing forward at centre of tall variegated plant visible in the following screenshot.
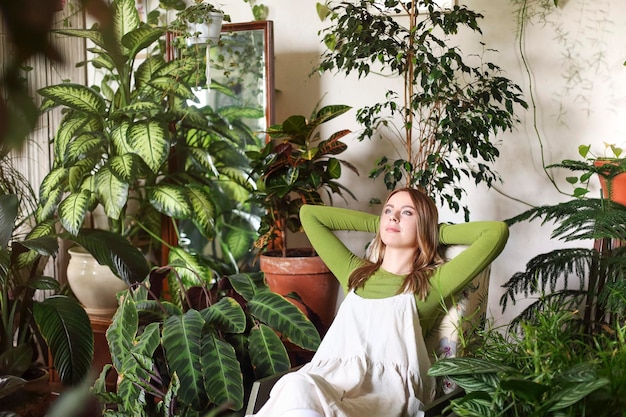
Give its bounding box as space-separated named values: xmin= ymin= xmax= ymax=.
xmin=126 ymin=120 xmax=169 ymax=175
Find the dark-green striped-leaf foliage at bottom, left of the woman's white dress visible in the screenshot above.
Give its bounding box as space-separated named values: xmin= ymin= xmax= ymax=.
xmin=93 ymin=263 xmax=320 ymax=416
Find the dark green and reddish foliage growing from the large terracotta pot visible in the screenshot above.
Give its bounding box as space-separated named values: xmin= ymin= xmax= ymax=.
xmin=248 ymin=105 xmax=358 ymax=256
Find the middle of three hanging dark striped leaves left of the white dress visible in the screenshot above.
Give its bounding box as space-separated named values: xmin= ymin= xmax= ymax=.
xmin=201 ymin=332 xmax=243 ymax=410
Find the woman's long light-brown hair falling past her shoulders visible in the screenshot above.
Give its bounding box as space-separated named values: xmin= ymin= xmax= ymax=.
xmin=348 ymin=188 xmax=443 ymax=299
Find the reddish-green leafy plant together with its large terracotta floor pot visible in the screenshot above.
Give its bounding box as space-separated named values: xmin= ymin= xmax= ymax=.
xmin=248 ymin=105 xmax=357 ymax=333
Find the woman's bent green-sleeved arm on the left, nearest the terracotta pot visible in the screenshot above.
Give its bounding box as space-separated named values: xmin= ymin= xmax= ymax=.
xmin=300 ymin=204 xmax=379 ymax=291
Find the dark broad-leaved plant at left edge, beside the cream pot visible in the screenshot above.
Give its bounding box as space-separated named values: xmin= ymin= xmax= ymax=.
xmin=0 ymin=194 xmax=93 ymax=406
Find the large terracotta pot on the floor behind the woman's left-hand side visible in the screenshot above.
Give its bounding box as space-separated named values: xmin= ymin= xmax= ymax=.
xmin=261 ymin=249 xmax=339 ymax=335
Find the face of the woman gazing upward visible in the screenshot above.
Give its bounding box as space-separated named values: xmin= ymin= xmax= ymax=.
xmin=380 ymin=191 xmax=417 ymax=248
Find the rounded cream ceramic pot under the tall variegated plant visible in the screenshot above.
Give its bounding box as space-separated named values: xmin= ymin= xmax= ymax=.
xmin=67 ymin=246 xmax=128 ymax=317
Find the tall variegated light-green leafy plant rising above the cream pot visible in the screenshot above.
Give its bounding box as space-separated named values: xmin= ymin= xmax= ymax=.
xmin=37 ymin=0 xmax=257 ymax=292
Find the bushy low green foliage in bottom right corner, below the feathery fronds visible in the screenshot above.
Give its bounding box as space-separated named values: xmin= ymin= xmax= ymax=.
xmin=429 ymin=303 xmax=626 ymax=417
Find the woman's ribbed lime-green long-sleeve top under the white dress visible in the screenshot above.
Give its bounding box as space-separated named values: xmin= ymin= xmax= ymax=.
xmin=300 ymin=205 xmax=509 ymax=335
